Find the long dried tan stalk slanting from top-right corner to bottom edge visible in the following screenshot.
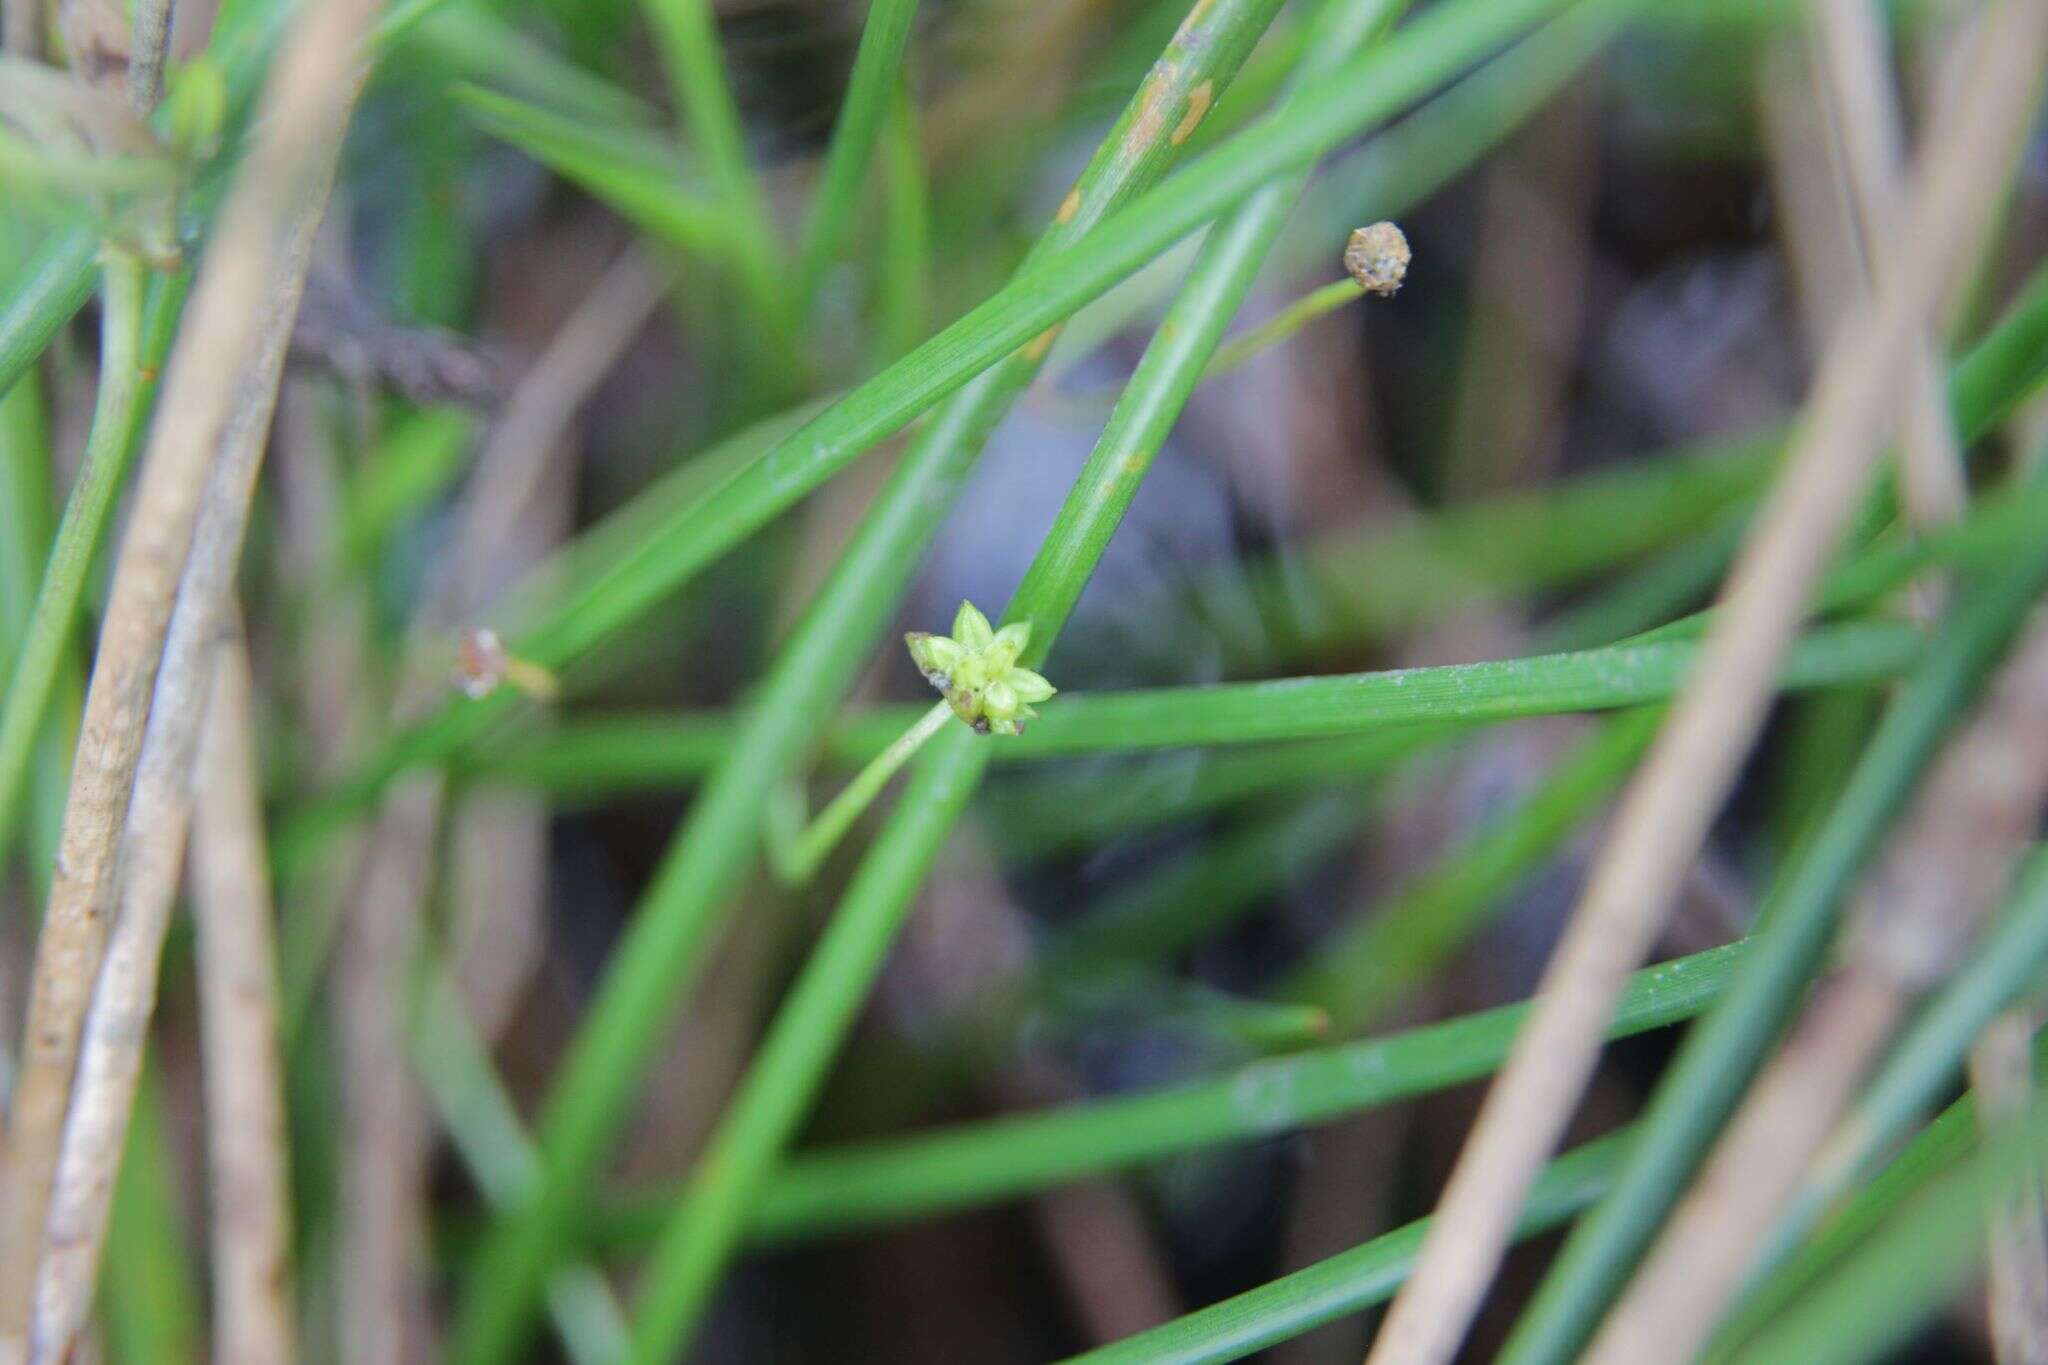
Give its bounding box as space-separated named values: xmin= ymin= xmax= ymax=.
xmin=1370 ymin=0 xmax=2048 ymax=1365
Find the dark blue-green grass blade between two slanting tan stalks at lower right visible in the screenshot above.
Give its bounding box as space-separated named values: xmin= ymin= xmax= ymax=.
xmin=1503 ymin=464 xmax=2048 ymax=1365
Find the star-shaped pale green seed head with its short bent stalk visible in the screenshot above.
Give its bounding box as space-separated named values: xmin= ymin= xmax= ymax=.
xmin=764 ymin=602 xmax=1055 ymax=886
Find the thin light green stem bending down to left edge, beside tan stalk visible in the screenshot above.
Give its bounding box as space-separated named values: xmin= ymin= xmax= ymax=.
xmin=0 ymin=248 xmax=145 ymax=879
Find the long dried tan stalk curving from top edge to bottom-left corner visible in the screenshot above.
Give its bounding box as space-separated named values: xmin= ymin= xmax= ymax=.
xmin=0 ymin=0 xmax=377 ymax=1363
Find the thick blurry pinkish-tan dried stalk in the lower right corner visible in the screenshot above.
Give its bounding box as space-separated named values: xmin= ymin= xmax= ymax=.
xmin=1587 ymin=620 xmax=2048 ymax=1365
